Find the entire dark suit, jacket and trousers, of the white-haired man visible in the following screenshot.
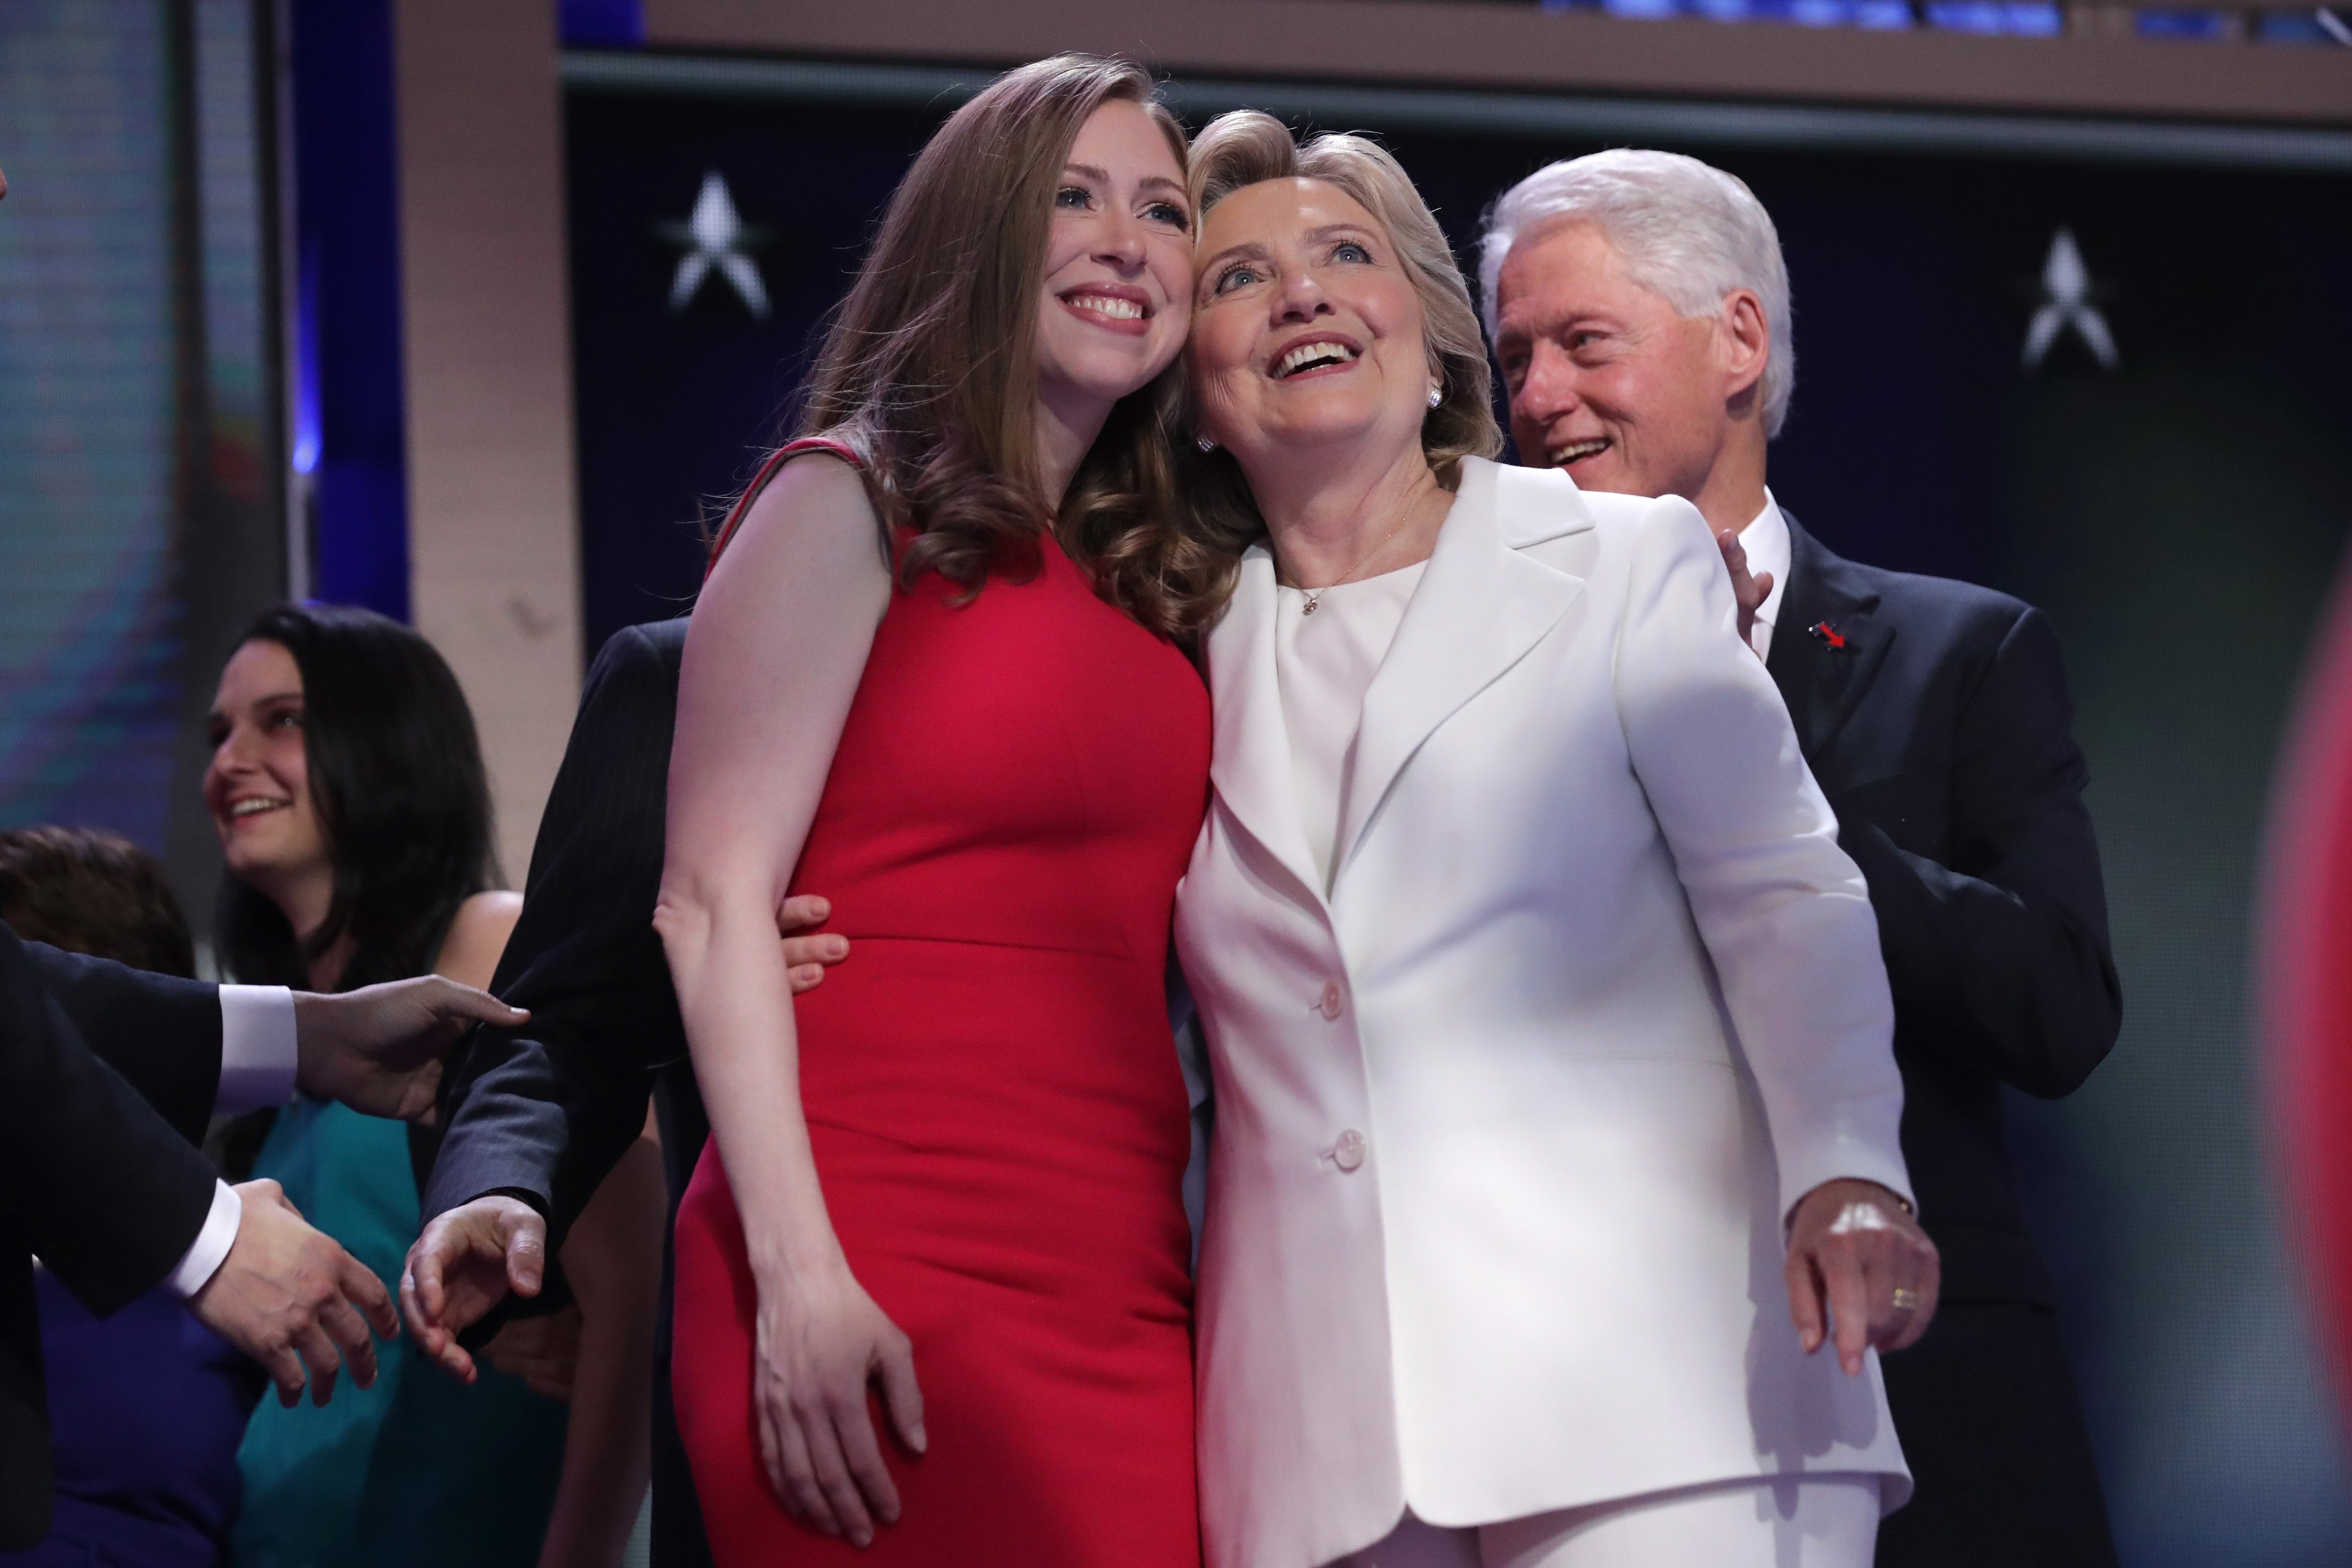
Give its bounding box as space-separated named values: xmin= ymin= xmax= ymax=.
xmin=1769 ymin=519 xmax=2122 ymax=1568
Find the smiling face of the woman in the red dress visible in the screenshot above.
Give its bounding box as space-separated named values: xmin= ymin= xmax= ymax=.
xmin=1037 ymin=99 xmax=1192 ymax=423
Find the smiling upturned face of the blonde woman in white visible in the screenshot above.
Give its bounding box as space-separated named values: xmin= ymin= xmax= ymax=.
xmin=1190 ymin=179 xmax=1437 ymax=470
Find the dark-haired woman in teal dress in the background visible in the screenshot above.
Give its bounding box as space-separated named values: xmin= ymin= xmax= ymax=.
xmin=205 ymin=606 xmax=661 ymax=1568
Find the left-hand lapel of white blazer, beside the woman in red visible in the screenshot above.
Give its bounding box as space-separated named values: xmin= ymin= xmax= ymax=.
xmin=1209 ymin=543 xmax=1322 ymax=908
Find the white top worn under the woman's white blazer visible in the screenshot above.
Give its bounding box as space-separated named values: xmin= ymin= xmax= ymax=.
xmin=1275 ymin=562 xmax=1428 ymax=891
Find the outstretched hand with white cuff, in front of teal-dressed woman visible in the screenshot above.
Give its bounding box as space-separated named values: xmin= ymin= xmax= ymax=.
xmin=294 ymin=976 xmax=529 ymax=1121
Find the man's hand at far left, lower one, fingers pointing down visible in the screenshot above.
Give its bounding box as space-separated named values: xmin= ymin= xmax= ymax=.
xmin=188 ymin=1180 xmax=400 ymax=1408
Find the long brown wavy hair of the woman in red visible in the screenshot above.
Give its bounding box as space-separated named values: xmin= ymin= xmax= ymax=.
xmin=753 ymin=54 xmax=1228 ymax=637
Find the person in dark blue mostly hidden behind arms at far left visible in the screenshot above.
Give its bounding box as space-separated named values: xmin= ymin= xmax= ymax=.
xmin=0 ymin=827 xmax=260 ymax=1568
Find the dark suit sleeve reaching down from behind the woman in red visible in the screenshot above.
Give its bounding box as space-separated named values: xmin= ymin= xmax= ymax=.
xmin=423 ymin=628 xmax=684 ymax=1253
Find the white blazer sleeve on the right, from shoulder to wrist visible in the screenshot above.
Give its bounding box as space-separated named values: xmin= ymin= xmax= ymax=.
xmin=1616 ymin=498 xmax=1912 ymax=1213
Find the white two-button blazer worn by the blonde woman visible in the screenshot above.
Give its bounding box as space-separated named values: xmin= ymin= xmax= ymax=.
xmin=1176 ymin=459 xmax=1910 ymax=1568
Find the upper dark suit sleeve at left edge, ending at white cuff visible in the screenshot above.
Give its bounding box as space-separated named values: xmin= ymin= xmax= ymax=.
xmin=21 ymin=943 xmax=221 ymax=1142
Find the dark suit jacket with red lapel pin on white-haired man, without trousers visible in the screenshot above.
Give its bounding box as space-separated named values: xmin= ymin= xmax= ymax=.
xmin=1769 ymin=522 xmax=2122 ymax=1302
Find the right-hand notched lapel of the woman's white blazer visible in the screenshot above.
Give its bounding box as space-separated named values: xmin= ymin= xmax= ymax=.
xmin=1335 ymin=459 xmax=1592 ymax=891
